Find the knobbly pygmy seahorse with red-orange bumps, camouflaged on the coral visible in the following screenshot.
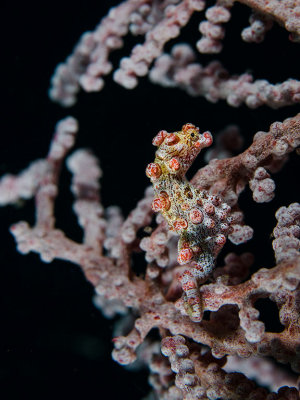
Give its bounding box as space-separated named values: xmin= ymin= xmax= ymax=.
xmin=146 ymin=124 xmax=231 ymax=320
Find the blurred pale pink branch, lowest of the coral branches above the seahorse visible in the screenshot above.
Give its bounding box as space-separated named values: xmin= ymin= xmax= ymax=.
xmin=150 ymin=44 xmax=300 ymax=108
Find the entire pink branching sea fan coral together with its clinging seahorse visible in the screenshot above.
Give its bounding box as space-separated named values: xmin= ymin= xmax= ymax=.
xmin=0 ymin=0 xmax=300 ymax=400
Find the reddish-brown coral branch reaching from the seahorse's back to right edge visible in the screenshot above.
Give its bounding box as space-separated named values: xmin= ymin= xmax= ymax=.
xmin=192 ymin=114 xmax=300 ymax=206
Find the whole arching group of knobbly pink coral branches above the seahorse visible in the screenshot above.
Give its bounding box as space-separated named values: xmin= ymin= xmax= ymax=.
xmin=49 ymin=0 xmax=300 ymax=108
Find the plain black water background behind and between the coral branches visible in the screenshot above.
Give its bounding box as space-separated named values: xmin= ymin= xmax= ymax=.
xmin=0 ymin=0 xmax=299 ymax=400
